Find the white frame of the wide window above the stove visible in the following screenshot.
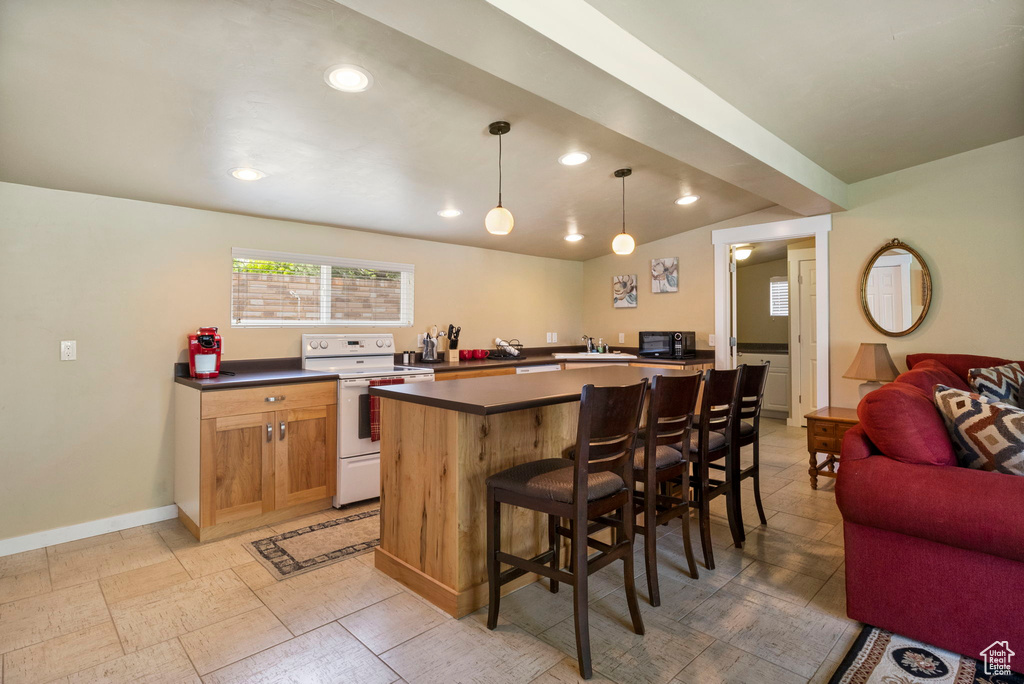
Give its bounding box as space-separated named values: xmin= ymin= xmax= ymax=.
xmin=228 ymin=247 xmax=416 ymax=328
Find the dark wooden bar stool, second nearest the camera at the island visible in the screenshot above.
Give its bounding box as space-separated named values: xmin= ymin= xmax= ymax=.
xmin=633 ymin=373 xmax=702 ymax=606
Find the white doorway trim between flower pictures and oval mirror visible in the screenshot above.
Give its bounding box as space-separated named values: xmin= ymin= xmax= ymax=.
xmin=712 ymin=215 xmax=831 ymax=413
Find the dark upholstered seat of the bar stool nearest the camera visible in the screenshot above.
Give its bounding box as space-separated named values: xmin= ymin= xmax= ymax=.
xmin=487 ymin=459 xmax=626 ymax=504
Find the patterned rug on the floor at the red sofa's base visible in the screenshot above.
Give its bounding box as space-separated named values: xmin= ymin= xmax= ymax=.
xmin=828 ymin=625 xmax=1024 ymax=684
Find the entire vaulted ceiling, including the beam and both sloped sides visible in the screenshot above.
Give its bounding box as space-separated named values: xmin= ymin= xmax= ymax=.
xmin=0 ymin=0 xmax=1024 ymax=260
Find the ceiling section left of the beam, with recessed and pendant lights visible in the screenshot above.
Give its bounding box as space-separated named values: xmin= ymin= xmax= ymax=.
xmin=0 ymin=0 xmax=773 ymax=259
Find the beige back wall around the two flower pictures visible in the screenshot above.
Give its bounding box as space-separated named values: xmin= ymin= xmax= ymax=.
xmin=583 ymin=208 xmax=795 ymax=349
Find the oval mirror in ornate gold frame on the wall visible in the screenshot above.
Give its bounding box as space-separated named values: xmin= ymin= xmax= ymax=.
xmin=860 ymin=239 xmax=932 ymax=337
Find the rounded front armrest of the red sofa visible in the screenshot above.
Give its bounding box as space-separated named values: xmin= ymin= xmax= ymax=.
xmin=836 ymin=456 xmax=1024 ymax=562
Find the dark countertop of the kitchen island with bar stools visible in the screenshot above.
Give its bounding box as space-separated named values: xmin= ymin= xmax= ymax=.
xmin=370 ymin=366 xmax=700 ymax=416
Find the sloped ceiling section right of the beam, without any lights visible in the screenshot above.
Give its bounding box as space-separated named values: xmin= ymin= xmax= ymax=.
xmin=587 ymin=0 xmax=1024 ymax=182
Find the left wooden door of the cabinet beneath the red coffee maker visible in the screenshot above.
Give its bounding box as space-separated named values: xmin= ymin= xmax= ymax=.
xmin=200 ymin=413 xmax=274 ymax=527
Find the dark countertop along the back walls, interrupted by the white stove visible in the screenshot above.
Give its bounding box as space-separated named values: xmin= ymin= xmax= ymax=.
xmin=174 ymin=351 xmax=714 ymax=390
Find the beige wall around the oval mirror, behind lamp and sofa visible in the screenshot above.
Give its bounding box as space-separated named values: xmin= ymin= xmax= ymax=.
xmin=829 ymin=137 xmax=1024 ymax=407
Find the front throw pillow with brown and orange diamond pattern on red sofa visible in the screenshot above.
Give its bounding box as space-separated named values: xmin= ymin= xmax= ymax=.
xmin=935 ymin=385 xmax=1024 ymax=475
